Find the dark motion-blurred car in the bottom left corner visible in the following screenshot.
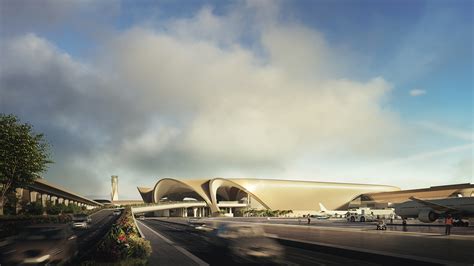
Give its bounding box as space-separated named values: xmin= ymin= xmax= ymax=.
xmin=0 ymin=224 xmax=77 ymax=265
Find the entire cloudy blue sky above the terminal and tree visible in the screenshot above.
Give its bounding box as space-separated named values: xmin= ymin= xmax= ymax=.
xmin=0 ymin=0 xmax=474 ymax=199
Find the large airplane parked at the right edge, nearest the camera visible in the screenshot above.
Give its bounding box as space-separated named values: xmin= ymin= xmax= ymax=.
xmin=395 ymin=197 xmax=474 ymax=223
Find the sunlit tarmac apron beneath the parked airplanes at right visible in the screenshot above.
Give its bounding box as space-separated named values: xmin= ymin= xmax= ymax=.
xmin=209 ymin=218 xmax=474 ymax=265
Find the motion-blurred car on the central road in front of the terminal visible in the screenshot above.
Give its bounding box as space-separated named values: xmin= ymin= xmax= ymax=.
xmin=213 ymin=224 xmax=285 ymax=264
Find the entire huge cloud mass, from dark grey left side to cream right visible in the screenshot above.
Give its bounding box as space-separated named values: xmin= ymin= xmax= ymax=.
xmin=0 ymin=3 xmax=403 ymax=196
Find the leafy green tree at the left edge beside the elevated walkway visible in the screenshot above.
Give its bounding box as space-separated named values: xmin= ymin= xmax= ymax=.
xmin=0 ymin=114 xmax=52 ymax=215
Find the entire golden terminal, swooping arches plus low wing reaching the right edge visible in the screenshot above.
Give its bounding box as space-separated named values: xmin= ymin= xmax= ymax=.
xmin=138 ymin=178 xmax=474 ymax=217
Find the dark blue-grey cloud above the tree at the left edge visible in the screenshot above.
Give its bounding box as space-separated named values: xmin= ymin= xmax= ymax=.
xmin=0 ymin=34 xmax=143 ymax=197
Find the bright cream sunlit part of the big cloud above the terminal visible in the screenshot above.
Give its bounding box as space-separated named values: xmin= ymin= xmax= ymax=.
xmin=104 ymin=23 xmax=398 ymax=161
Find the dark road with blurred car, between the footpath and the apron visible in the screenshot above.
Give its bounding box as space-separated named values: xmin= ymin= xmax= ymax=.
xmin=139 ymin=219 xmax=396 ymax=265
